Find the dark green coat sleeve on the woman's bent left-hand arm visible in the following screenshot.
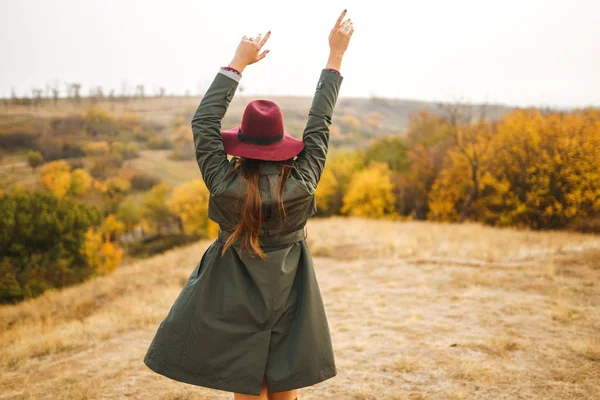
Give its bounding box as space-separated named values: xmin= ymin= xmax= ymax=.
xmin=192 ymin=68 xmax=239 ymax=193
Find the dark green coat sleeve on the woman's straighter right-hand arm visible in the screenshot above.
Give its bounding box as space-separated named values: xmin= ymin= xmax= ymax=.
xmin=295 ymin=69 xmax=343 ymax=190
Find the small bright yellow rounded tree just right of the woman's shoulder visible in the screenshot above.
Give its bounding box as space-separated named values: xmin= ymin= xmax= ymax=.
xmin=341 ymin=161 xmax=397 ymax=218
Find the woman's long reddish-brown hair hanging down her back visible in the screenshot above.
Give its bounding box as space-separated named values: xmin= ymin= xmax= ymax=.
xmin=221 ymin=157 xmax=294 ymax=260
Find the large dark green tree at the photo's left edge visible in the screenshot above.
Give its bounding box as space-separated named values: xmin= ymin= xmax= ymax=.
xmin=0 ymin=190 xmax=101 ymax=302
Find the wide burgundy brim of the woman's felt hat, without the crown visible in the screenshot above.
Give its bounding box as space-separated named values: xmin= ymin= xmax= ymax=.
xmin=221 ymin=126 xmax=304 ymax=161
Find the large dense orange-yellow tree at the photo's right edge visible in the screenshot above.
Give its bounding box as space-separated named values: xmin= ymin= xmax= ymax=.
xmin=430 ymin=109 xmax=600 ymax=229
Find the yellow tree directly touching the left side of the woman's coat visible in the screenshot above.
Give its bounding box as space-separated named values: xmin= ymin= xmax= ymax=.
xmin=168 ymin=179 xmax=210 ymax=236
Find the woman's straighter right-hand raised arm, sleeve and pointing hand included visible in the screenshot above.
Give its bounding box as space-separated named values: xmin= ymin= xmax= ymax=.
xmin=296 ymin=10 xmax=354 ymax=190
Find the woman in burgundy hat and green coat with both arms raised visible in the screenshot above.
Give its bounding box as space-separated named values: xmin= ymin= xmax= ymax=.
xmin=144 ymin=10 xmax=354 ymax=400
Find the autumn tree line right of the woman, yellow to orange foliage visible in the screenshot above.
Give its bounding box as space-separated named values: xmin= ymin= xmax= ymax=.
xmin=317 ymin=105 xmax=600 ymax=232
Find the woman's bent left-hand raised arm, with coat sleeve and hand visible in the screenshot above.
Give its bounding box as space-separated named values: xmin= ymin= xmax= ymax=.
xmin=192 ymin=32 xmax=271 ymax=193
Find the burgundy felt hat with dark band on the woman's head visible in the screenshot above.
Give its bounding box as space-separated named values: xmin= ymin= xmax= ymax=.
xmin=221 ymin=100 xmax=304 ymax=161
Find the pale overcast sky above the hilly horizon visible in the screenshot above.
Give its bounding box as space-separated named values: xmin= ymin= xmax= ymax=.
xmin=0 ymin=0 xmax=600 ymax=106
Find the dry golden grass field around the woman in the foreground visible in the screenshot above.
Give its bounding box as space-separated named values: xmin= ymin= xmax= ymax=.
xmin=0 ymin=217 xmax=600 ymax=400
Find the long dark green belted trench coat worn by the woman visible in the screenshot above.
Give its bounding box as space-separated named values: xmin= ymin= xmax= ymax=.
xmin=144 ymin=69 xmax=343 ymax=395
